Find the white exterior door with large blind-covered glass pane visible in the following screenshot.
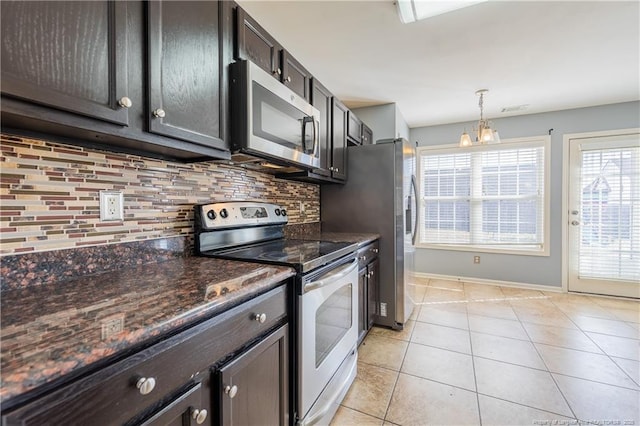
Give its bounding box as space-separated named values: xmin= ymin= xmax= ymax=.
xmin=568 ymin=132 xmax=640 ymax=298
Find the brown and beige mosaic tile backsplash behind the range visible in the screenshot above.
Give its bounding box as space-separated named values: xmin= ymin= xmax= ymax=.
xmin=0 ymin=134 xmax=320 ymax=256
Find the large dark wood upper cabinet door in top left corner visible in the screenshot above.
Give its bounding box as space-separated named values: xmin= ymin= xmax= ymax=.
xmin=0 ymin=1 xmax=129 ymax=125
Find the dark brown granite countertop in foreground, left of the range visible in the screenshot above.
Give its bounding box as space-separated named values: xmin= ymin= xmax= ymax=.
xmin=0 ymin=257 xmax=294 ymax=405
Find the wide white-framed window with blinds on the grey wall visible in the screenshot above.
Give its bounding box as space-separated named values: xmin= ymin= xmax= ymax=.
xmin=418 ymin=136 xmax=550 ymax=255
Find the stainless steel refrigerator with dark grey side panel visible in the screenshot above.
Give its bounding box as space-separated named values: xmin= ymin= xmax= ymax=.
xmin=320 ymin=139 xmax=418 ymax=329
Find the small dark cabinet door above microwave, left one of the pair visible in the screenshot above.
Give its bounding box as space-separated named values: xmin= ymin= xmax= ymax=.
xmin=234 ymin=7 xmax=282 ymax=80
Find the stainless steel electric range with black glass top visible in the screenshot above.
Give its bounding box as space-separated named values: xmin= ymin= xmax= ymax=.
xmin=195 ymin=201 xmax=358 ymax=425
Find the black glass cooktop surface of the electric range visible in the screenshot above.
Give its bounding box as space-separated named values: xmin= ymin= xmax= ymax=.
xmin=203 ymin=239 xmax=357 ymax=273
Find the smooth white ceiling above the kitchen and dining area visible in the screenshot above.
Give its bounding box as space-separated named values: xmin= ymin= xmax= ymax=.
xmin=238 ymin=0 xmax=640 ymax=127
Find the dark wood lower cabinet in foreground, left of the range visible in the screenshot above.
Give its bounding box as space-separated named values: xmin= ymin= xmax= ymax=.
xmin=2 ymin=284 xmax=289 ymax=426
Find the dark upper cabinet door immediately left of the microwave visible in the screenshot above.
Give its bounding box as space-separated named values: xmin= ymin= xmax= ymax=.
xmin=147 ymin=1 xmax=225 ymax=149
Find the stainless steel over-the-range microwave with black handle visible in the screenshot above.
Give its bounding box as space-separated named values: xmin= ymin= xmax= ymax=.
xmin=229 ymin=61 xmax=320 ymax=169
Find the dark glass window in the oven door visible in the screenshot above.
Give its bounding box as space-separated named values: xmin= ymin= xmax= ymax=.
xmin=316 ymin=284 xmax=353 ymax=368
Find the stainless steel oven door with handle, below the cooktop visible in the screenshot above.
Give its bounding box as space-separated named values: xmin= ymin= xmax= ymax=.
xmin=298 ymin=258 xmax=358 ymax=418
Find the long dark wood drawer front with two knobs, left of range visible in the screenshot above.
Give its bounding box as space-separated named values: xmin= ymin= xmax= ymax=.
xmin=2 ymin=285 xmax=287 ymax=425
